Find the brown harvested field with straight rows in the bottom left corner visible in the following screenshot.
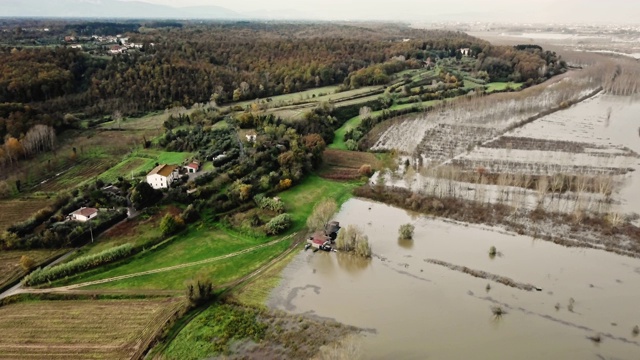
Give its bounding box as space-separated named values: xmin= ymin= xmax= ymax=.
xmin=0 ymin=299 xmax=182 ymax=359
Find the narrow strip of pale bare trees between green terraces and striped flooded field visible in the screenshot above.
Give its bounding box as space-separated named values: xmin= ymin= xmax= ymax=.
xmin=371 ymin=72 xmax=599 ymax=160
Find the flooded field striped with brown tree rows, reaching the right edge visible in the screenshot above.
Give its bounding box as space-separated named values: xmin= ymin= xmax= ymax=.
xmin=376 ymin=90 xmax=640 ymax=225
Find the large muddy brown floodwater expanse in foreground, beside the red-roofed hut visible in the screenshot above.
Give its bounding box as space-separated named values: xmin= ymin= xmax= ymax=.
xmin=269 ymin=199 xmax=640 ymax=359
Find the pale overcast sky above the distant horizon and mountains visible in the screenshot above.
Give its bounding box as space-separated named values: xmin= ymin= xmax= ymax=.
xmin=125 ymin=0 xmax=640 ymax=23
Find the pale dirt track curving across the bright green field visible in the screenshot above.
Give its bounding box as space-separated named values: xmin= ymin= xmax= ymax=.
xmin=11 ymin=233 xmax=297 ymax=295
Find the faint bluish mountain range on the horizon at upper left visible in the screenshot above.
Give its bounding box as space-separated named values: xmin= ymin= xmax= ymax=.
xmin=0 ymin=0 xmax=242 ymax=19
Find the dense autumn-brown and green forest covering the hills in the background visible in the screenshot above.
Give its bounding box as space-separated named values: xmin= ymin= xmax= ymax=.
xmin=0 ymin=22 xmax=564 ymax=142
